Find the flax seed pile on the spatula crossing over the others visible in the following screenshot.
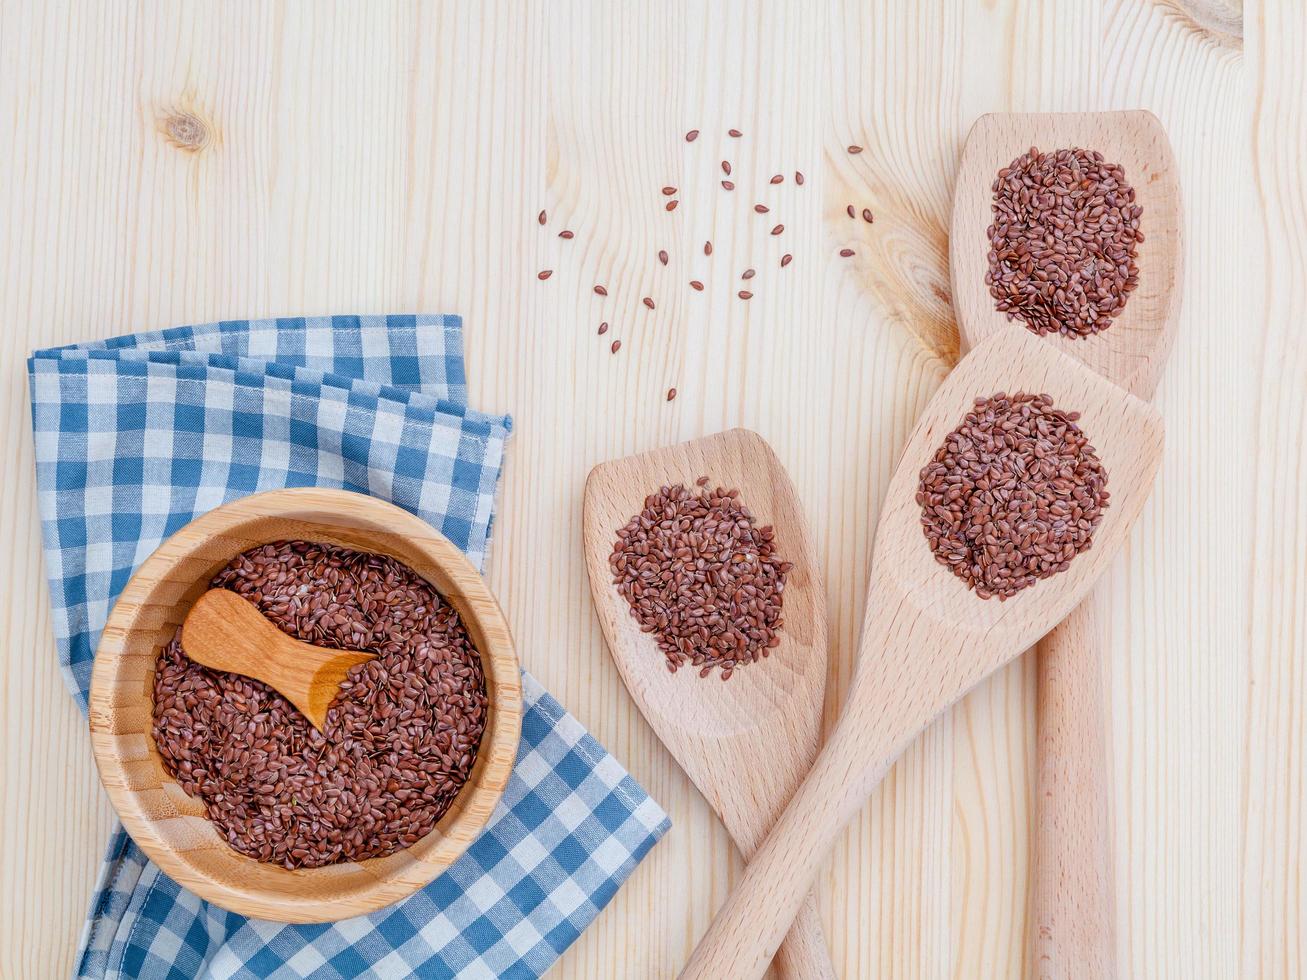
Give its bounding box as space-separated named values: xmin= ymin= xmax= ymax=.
xmin=916 ymin=392 xmax=1111 ymax=601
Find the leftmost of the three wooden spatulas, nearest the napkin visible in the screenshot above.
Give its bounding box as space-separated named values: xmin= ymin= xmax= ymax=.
xmin=584 ymin=429 xmax=835 ymax=977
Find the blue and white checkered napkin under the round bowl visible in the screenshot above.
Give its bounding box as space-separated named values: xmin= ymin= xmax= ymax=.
xmin=29 ymin=316 xmax=669 ymax=980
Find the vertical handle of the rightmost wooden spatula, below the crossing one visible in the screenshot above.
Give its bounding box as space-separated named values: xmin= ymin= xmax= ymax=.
xmin=1034 ymin=595 xmax=1116 ymax=980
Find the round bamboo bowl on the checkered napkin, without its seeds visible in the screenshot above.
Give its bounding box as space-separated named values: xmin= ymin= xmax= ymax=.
xmin=90 ymin=487 xmax=521 ymax=923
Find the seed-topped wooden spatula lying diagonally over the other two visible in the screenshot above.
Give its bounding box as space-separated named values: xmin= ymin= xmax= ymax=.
xmin=682 ymin=331 xmax=1162 ymax=980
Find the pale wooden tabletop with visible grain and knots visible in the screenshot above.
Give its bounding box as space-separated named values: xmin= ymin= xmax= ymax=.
xmin=0 ymin=0 xmax=1307 ymax=980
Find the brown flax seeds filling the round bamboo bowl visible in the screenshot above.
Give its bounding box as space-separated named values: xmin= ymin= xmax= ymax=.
xmin=153 ymin=541 xmax=488 ymax=868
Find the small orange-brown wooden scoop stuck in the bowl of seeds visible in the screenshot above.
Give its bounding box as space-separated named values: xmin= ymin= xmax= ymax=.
xmin=182 ymin=589 xmax=374 ymax=732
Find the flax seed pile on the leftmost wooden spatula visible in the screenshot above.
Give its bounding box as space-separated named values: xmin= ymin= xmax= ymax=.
xmin=608 ymin=477 xmax=793 ymax=681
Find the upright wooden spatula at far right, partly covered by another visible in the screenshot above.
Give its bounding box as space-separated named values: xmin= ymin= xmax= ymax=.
xmin=949 ymin=111 xmax=1182 ymax=980
